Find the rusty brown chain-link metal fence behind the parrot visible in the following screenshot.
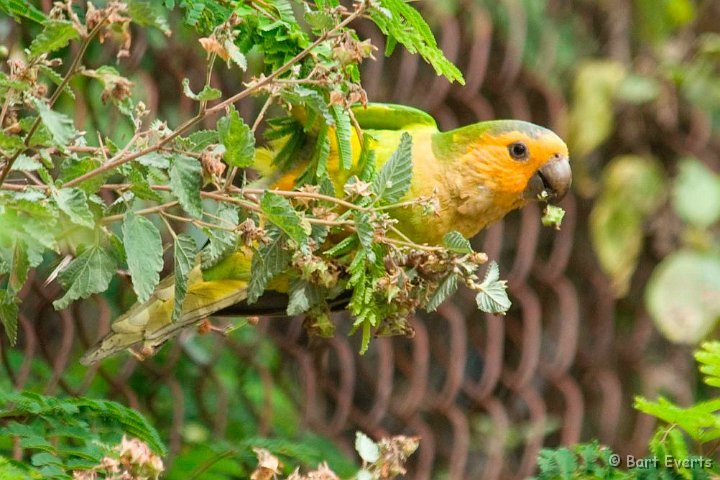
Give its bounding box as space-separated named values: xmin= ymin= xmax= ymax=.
xmin=0 ymin=1 xmax=711 ymax=479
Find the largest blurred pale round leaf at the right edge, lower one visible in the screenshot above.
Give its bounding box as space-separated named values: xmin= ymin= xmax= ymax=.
xmin=645 ymin=250 xmax=720 ymax=344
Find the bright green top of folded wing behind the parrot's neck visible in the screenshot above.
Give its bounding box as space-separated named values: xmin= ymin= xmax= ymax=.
xmin=352 ymin=103 xmax=437 ymax=130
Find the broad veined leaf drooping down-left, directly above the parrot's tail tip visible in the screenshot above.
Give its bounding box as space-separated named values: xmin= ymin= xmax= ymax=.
xmin=53 ymin=245 xmax=117 ymax=310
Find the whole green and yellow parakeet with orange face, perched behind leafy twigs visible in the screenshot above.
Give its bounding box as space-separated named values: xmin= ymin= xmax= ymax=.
xmin=81 ymin=104 xmax=572 ymax=364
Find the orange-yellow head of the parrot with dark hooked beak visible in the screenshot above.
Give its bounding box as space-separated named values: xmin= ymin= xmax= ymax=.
xmin=434 ymin=120 xmax=572 ymax=236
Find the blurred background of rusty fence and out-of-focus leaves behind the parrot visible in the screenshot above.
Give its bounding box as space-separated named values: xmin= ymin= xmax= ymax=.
xmin=0 ymin=0 xmax=720 ymax=479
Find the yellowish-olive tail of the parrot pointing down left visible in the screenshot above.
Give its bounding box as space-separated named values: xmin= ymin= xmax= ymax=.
xmin=80 ymin=266 xmax=247 ymax=365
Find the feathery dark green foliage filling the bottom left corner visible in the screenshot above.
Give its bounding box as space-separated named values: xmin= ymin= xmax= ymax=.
xmin=0 ymin=391 xmax=165 ymax=479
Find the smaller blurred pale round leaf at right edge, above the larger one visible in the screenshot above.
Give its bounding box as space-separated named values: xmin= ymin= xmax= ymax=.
xmin=672 ymin=158 xmax=720 ymax=228
